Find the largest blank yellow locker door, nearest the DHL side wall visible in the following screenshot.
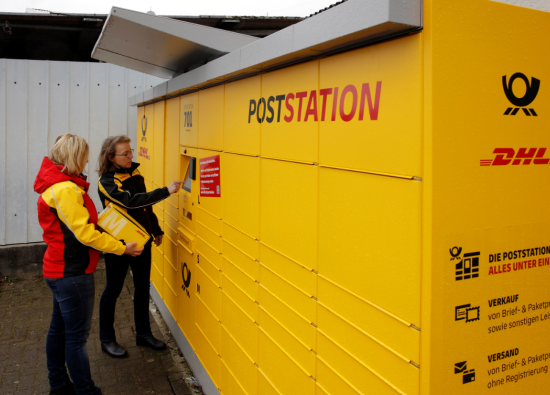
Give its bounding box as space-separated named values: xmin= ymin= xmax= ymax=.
xmin=319 ymin=168 xmax=421 ymax=327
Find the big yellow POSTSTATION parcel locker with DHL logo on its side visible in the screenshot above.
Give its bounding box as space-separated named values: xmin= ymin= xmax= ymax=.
xmin=109 ymin=0 xmax=550 ymax=395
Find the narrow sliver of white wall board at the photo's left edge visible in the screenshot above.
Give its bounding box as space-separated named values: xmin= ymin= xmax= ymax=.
xmin=0 ymin=59 xmax=7 ymax=245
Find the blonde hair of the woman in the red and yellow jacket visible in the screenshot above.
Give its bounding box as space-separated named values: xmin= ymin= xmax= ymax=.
xmin=49 ymin=133 xmax=90 ymax=175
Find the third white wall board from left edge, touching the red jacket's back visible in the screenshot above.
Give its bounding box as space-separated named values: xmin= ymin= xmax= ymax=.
xmin=27 ymin=60 xmax=49 ymax=243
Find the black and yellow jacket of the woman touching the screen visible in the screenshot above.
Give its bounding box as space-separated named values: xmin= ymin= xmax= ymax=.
xmin=98 ymin=162 xmax=170 ymax=236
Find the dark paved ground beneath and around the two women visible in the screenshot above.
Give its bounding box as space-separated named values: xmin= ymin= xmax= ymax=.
xmin=0 ymin=262 xmax=202 ymax=395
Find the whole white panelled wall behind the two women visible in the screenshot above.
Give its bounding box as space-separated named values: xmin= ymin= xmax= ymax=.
xmin=0 ymin=59 xmax=164 ymax=245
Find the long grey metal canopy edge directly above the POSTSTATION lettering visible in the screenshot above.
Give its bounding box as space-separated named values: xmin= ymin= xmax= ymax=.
xmin=131 ymin=0 xmax=422 ymax=105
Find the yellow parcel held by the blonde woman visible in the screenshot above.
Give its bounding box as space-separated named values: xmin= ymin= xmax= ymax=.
xmin=97 ymin=204 xmax=151 ymax=248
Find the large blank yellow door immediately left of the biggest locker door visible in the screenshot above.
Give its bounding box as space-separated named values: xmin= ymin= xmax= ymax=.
xmin=260 ymin=159 xmax=320 ymax=269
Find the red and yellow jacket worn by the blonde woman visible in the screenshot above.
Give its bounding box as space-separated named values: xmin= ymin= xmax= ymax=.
xmin=34 ymin=158 xmax=126 ymax=278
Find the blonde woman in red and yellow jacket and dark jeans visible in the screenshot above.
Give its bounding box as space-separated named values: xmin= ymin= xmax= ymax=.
xmin=34 ymin=134 xmax=143 ymax=395
